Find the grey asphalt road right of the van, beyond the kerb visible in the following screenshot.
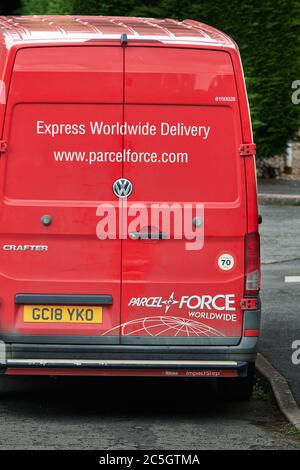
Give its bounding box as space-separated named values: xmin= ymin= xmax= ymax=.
xmin=260 ymin=206 xmax=300 ymax=405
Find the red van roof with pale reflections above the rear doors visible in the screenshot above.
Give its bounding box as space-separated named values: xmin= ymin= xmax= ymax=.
xmin=0 ymin=16 xmax=237 ymax=48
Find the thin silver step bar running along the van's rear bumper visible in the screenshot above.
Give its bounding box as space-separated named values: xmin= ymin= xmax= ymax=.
xmin=5 ymin=359 xmax=247 ymax=370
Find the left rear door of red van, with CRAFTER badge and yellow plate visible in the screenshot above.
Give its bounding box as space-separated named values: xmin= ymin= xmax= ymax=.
xmin=0 ymin=45 xmax=123 ymax=343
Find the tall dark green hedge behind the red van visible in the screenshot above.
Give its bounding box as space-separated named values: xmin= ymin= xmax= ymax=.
xmin=22 ymin=0 xmax=300 ymax=157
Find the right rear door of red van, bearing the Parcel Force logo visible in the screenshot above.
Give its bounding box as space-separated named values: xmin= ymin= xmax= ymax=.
xmin=121 ymin=45 xmax=246 ymax=345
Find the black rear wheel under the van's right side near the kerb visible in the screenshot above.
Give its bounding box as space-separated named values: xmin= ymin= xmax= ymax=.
xmin=218 ymin=363 xmax=255 ymax=401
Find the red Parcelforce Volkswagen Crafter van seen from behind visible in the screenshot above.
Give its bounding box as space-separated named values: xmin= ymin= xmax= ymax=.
xmin=0 ymin=16 xmax=260 ymax=398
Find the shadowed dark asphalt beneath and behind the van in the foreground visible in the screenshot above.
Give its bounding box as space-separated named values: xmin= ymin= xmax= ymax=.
xmin=0 ymin=377 xmax=300 ymax=450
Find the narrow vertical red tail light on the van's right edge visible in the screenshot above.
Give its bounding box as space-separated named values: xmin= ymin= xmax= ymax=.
xmin=245 ymin=232 xmax=260 ymax=295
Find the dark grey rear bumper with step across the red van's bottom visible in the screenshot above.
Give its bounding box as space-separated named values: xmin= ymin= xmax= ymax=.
xmin=0 ymin=337 xmax=258 ymax=377
